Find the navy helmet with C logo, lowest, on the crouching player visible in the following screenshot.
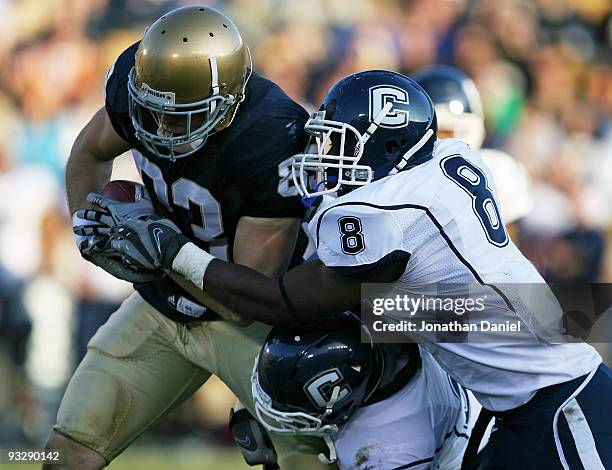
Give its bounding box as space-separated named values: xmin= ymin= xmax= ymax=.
xmin=251 ymin=313 xmax=383 ymax=449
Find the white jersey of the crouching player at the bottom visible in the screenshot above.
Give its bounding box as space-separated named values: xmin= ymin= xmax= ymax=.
xmin=332 ymin=348 xmax=480 ymax=470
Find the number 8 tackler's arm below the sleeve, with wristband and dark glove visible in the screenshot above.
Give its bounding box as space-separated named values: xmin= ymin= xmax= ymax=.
xmin=106 ymin=213 xmax=378 ymax=326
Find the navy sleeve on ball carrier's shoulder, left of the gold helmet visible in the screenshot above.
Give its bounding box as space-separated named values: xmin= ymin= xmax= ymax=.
xmin=104 ymin=42 xmax=139 ymax=142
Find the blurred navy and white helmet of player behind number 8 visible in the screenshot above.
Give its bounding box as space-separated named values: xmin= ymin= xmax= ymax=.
xmin=411 ymin=65 xmax=485 ymax=150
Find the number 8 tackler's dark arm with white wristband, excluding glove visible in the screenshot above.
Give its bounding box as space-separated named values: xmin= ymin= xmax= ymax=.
xmin=167 ymin=237 xmax=364 ymax=326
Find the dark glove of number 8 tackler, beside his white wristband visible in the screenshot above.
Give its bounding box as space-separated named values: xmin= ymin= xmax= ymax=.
xmin=110 ymin=215 xmax=190 ymax=270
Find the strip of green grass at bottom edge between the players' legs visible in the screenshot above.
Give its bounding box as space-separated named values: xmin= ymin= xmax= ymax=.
xmin=0 ymin=445 xmax=249 ymax=470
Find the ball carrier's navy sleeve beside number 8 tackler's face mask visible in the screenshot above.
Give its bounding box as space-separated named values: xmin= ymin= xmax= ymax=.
xmin=230 ymin=97 xmax=308 ymax=217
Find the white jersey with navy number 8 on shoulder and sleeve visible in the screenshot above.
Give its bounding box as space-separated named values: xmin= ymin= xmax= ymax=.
xmin=309 ymin=139 xmax=601 ymax=411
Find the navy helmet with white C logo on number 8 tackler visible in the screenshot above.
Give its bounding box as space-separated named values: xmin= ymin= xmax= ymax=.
xmin=292 ymin=70 xmax=437 ymax=198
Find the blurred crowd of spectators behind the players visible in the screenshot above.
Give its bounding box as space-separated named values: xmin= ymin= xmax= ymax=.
xmin=0 ymin=0 xmax=612 ymax=462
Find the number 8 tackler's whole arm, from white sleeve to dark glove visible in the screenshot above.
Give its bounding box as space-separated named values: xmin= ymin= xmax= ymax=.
xmin=111 ymin=200 xmax=410 ymax=326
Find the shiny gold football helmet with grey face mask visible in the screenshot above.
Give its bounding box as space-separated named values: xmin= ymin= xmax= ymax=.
xmin=128 ymin=5 xmax=250 ymax=160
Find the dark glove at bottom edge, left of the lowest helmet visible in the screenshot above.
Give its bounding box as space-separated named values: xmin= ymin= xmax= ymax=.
xmin=229 ymin=408 xmax=278 ymax=469
